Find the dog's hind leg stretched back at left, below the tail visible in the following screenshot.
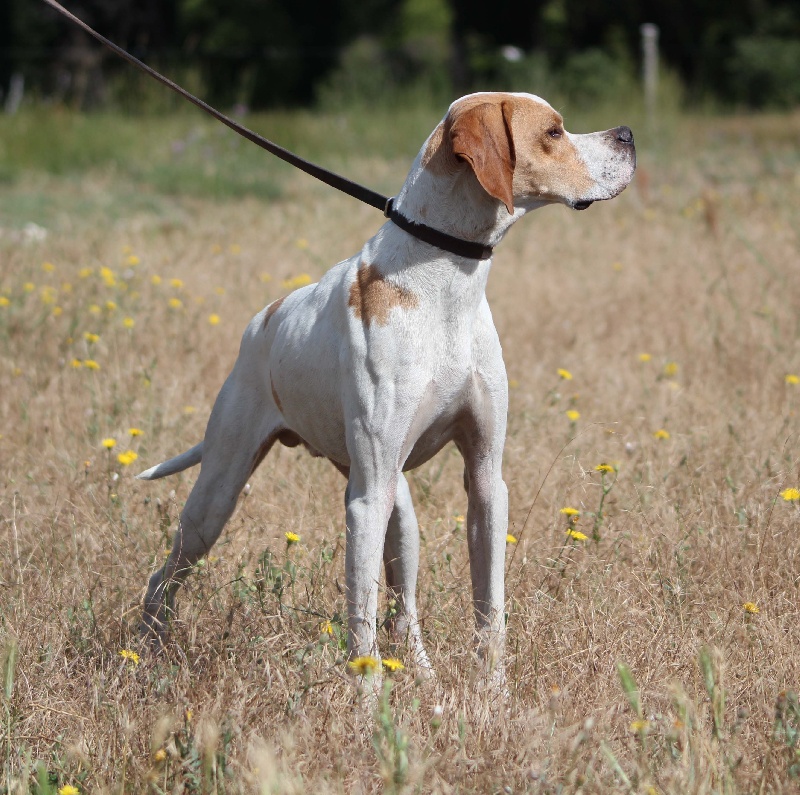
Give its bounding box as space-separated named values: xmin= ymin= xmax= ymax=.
xmin=141 ymin=371 xmax=283 ymax=641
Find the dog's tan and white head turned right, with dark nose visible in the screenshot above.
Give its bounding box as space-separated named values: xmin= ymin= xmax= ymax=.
xmin=423 ymin=93 xmax=636 ymax=214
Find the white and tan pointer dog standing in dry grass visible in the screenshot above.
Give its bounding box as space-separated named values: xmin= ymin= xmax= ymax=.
xmin=138 ymin=93 xmax=636 ymax=680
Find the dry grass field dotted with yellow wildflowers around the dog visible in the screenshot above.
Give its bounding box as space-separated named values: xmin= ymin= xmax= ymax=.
xmin=0 ymin=102 xmax=800 ymax=795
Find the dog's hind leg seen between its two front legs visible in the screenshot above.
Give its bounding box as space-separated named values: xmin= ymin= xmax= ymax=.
xmin=383 ymin=474 xmax=433 ymax=676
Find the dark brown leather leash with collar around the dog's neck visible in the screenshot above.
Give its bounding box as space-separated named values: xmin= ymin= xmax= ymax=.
xmin=44 ymin=0 xmax=492 ymax=259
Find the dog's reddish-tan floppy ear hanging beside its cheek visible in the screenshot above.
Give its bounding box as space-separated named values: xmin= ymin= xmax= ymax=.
xmin=450 ymin=102 xmax=516 ymax=213
